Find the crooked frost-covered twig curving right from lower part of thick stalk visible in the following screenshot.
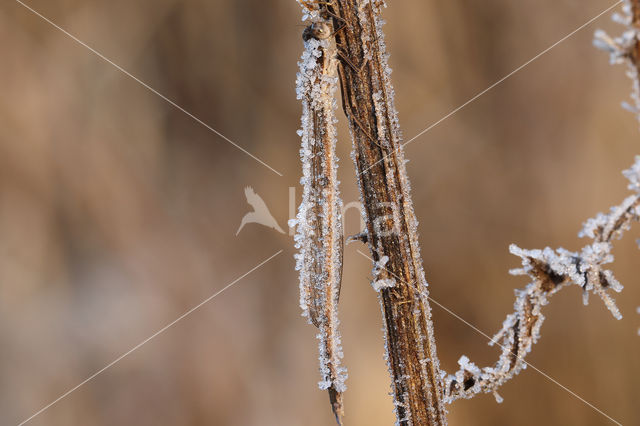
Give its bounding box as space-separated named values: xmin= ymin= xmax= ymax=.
xmin=443 ymin=157 xmax=640 ymax=402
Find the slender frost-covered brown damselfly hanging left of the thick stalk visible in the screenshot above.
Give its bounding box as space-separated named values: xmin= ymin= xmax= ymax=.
xmin=291 ymin=2 xmax=347 ymax=423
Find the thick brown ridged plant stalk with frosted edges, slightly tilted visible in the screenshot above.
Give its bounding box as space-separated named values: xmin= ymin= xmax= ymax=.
xmin=325 ymin=0 xmax=446 ymax=426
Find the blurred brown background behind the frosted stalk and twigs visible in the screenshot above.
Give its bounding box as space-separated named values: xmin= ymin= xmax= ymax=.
xmin=0 ymin=0 xmax=640 ymax=426
